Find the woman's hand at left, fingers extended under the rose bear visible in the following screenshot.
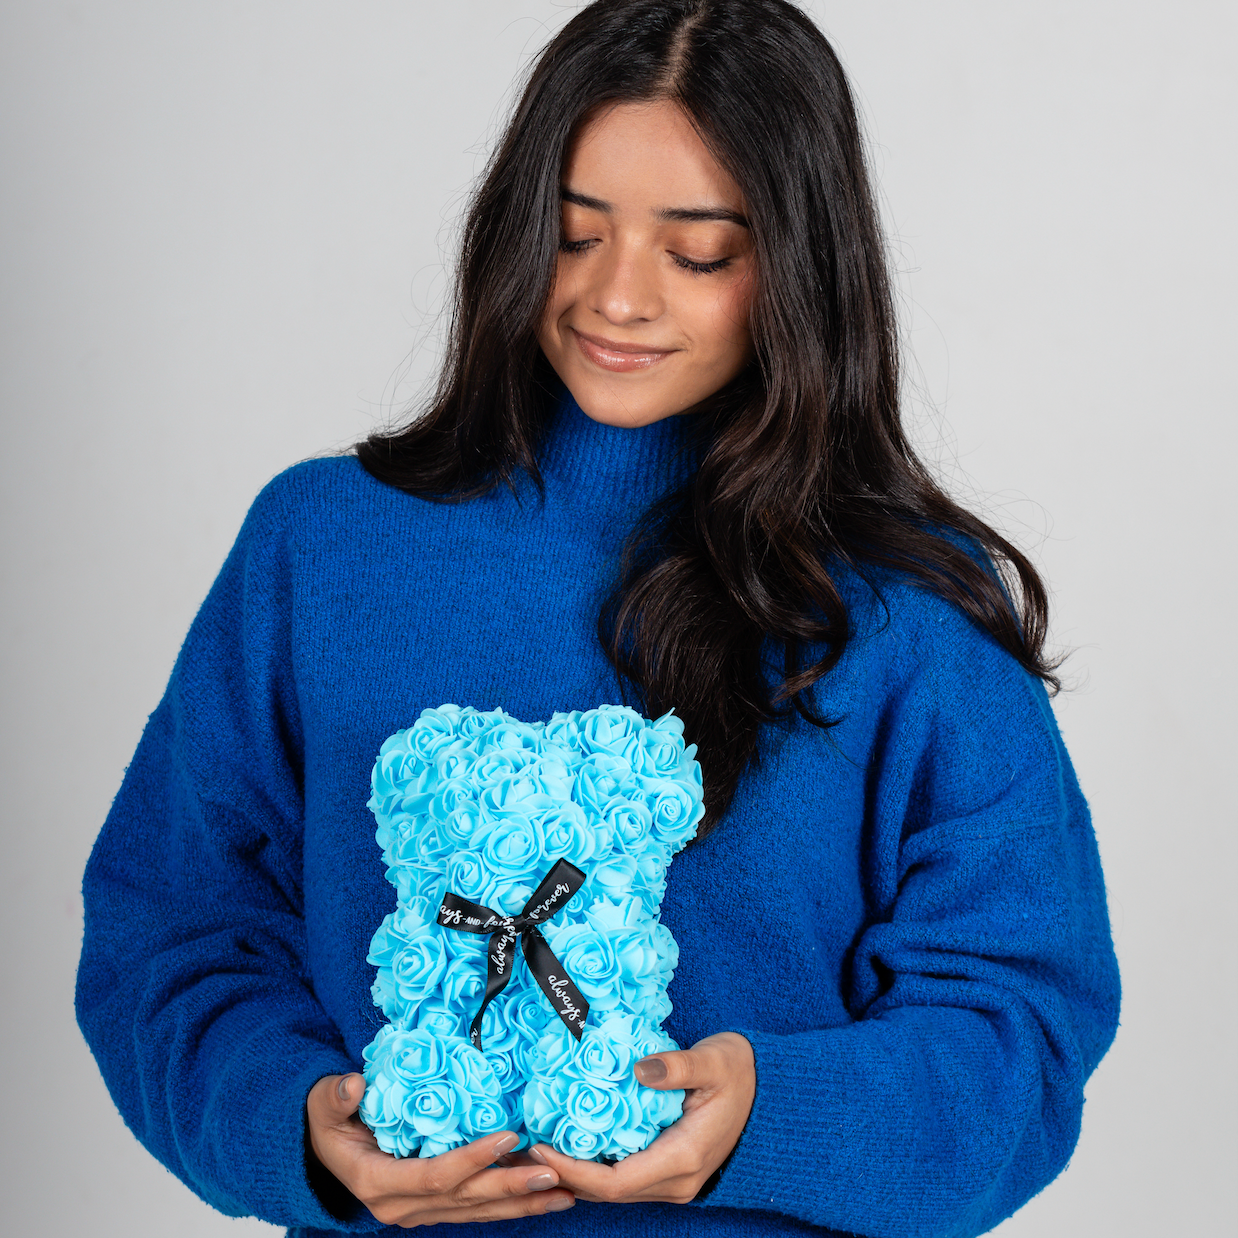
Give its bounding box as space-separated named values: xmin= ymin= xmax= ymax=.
xmin=306 ymin=1075 xmax=576 ymax=1228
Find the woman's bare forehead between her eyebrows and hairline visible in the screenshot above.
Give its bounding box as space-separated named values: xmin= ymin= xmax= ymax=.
xmin=563 ymin=100 xmax=743 ymax=213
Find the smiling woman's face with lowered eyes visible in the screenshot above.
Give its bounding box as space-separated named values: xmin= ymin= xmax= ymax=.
xmin=537 ymin=102 xmax=755 ymax=426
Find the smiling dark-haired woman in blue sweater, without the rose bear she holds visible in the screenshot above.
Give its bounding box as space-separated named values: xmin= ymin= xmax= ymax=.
xmin=78 ymin=0 xmax=1118 ymax=1236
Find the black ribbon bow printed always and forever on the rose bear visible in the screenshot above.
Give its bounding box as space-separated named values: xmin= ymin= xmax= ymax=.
xmin=438 ymin=859 xmax=589 ymax=1049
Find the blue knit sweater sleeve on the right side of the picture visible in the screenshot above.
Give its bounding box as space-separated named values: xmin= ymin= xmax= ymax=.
xmin=703 ymin=594 xmax=1119 ymax=1238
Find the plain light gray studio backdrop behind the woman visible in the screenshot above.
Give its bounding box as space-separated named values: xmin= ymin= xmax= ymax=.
xmin=0 ymin=0 xmax=1238 ymax=1238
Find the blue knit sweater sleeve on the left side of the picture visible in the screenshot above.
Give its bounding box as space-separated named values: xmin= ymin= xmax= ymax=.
xmin=77 ymin=478 xmax=378 ymax=1229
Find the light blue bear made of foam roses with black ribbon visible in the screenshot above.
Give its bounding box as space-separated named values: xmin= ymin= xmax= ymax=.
xmin=360 ymin=704 xmax=704 ymax=1161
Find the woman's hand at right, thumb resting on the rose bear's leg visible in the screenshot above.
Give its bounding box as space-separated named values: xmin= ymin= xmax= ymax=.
xmin=529 ymin=1031 xmax=756 ymax=1203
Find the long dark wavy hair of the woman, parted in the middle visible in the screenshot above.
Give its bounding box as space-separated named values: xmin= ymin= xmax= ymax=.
xmin=358 ymin=0 xmax=1057 ymax=832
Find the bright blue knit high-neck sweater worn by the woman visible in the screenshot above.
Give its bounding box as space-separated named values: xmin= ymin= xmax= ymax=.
xmin=78 ymin=401 xmax=1118 ymax=1238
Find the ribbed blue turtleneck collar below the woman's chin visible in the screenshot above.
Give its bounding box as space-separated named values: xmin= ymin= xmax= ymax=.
xmin=539 ymin=387 xmax=701 ymax=508
